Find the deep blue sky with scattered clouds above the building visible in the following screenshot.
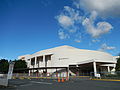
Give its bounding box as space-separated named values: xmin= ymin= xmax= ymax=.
xmin=0 ymin=0 xmax=120 ymax=60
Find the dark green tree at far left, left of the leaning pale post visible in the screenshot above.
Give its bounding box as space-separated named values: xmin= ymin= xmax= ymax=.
xmin=0 ymin=59 xmax=9 ymax=73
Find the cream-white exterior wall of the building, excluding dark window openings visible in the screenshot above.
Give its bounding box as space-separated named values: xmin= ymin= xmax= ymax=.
xmin=19 ymin=46 xmax=116 ymax=73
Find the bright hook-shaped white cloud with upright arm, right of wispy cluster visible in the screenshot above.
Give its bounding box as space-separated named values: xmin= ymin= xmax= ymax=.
xmin=82 ymin=11 xmax=113 ymax=38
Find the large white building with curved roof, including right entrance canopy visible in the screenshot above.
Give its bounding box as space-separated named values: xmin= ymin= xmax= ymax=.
xmin=18 ymin=45 xmax=116 ymax=75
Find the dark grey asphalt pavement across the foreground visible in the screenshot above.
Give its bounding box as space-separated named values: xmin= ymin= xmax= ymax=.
xmin=0 ymin=79 xmax=120 ymax=90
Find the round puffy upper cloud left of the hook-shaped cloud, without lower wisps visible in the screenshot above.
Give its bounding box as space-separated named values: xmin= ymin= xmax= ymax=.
xmin=56 ymin=6 xmax=82 ymax=32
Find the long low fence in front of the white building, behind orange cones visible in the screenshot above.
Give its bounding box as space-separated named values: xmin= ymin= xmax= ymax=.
xmin=13 ymin=71 xmax=90 ymax=80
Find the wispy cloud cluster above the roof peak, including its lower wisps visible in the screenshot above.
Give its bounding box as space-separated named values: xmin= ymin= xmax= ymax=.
xmin=55 ymin=6 xmax=83 ymax=42
